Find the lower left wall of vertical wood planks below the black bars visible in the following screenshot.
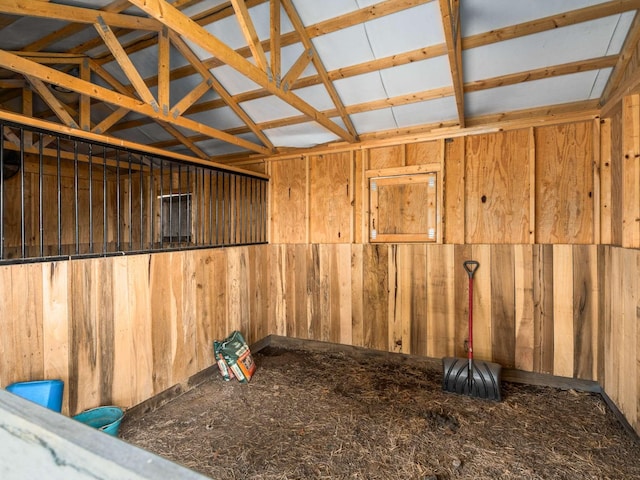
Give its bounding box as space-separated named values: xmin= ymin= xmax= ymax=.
xmin=0 ymin=246 xmax=269 ymax=414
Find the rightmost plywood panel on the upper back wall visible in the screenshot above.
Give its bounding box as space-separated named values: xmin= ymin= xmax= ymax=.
xmin=535 ymin=122 xmax=594 ymax=243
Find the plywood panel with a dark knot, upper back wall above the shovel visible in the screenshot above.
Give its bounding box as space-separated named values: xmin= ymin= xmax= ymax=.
xmin=465 ymin=130 xmax=531 ymax=243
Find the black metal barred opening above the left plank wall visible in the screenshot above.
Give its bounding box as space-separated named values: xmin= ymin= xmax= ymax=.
xmin=0 ymin=122 xmax=268 ymax=263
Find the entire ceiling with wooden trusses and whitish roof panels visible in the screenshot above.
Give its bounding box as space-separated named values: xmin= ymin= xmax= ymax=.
xmin=0 ymin=0 xmax=640 ymax=163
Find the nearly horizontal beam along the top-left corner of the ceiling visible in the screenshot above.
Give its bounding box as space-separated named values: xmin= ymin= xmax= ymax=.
xmin=0 ymin=0 xmax=162 ymax=32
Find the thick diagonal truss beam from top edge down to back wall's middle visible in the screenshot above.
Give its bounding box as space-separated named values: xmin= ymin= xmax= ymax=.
xmin=130 ymin=0 xmax=355 ymax=142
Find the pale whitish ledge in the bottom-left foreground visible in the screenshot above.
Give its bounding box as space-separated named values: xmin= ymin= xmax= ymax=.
xmin=0 ymin=389 xmax=207 ymax=480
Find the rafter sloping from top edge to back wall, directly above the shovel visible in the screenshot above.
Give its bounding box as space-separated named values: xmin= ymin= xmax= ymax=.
xmin=439 ymin=0 xmax=464 ymax=128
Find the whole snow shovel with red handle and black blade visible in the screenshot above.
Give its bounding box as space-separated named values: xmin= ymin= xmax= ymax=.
xmin=442 ymin=260 xmax=502 ymax=402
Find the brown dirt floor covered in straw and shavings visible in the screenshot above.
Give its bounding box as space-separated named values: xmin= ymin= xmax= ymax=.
xmin=120 ymin=347 xmax=640 ymax=480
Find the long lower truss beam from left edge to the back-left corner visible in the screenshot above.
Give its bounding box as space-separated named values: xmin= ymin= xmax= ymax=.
xmin=0 ymin=50 xmax=269 ymax=154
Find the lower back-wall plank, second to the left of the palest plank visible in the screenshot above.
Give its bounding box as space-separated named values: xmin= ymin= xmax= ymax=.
xmin=514 ymin=245 xmax=535 ymax=372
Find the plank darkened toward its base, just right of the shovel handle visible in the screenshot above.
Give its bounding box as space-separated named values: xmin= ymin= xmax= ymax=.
xmin=491 ymin=245 xmax=516 ymax=368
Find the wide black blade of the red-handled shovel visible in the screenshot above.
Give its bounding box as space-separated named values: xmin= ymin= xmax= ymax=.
xmin=442 ymin=357 xmax=502 ymax=402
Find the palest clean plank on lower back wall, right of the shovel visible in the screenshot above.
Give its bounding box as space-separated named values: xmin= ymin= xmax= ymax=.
xmin=553 ymin=245 xmax=574 ymax=377
